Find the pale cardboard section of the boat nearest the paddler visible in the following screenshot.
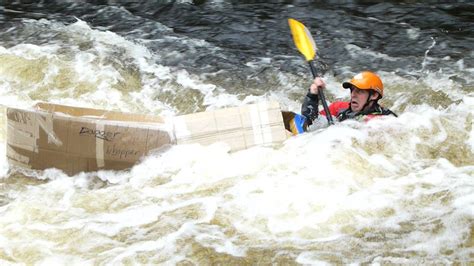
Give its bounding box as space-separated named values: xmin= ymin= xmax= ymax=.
xmin=174 ymin=102 xmax=287 ymax=151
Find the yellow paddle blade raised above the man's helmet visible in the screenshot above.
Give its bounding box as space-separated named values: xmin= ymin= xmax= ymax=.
xmin=288 ymin=18 xmax=316 ymax=61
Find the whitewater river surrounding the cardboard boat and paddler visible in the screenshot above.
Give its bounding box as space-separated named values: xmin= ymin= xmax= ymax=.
xmin=0 ymin=0 xmax=474 ymax=265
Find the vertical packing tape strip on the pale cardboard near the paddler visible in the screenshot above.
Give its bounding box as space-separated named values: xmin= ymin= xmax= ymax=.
xmin=250 ymin=103 xmax=273 ymax=144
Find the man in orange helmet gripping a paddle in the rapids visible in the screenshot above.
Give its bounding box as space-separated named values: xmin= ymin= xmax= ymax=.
xmin=301 ymin=71 xmax=397 ymax=125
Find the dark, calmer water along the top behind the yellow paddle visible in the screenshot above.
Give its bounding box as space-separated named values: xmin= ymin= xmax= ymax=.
xmin=0 ymin=1 xmax=474 ymax=84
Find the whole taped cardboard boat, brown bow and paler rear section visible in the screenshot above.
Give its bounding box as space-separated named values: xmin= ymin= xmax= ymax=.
xmin=7 ymin=102 xmax=304 ymax=175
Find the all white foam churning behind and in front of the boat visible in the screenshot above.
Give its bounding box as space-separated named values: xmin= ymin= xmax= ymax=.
xmin=0 ymin=13 xmax=474 ymax=264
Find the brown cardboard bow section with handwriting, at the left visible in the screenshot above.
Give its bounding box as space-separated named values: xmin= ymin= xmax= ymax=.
xmin=7 ymin=104 xmax=174 ymax=175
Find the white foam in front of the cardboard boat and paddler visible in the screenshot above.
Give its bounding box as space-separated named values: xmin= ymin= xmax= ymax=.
xmin=2 ymin=91 xmax=474 ymax=263
